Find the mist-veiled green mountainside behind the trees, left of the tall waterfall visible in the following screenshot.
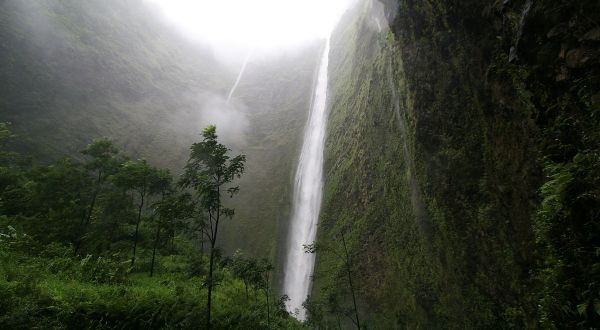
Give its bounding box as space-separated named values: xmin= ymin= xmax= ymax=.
xmin=0 ymin=0 xmax=320 ymax=259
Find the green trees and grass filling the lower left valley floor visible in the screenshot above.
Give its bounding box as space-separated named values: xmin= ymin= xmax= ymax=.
xmin=0 ymin=124 xmax=302 ymax=329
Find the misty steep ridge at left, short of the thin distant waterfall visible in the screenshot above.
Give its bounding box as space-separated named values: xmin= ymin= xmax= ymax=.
xmin=0 ymin=1 xmax=227 ymax=162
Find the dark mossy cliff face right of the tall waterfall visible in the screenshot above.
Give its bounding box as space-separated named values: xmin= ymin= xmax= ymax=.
xmin=310 ymin=0 xmax=600 ymax=329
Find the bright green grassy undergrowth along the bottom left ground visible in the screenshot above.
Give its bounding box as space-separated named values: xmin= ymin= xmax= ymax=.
xmin=0 ymin=251 xmax=302 ymax=329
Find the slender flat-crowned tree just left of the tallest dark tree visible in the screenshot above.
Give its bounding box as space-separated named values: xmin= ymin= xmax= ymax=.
xmin=113 ymin=160 xmax=161 ymax=267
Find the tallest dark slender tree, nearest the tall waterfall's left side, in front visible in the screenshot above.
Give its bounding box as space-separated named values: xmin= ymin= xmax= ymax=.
xmin=179 ymin=125 xmax=246 ymax=329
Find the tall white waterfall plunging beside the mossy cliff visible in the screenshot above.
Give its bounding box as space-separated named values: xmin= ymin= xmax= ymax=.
xmin=283 ymin=39 xmax=329 ymax=320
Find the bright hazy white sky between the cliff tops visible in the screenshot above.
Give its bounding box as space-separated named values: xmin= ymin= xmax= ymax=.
xmin=148 ymin=0 xmax=352 ymax=50
